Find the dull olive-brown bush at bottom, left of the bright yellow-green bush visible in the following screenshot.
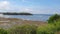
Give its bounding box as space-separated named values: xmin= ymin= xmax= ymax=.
xmin=9 ymin=25 xmax=36 ymax=34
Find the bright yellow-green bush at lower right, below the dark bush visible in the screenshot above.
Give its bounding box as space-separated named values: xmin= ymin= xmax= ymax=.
xmin=37 ymin=24 xmax=56 ymax=34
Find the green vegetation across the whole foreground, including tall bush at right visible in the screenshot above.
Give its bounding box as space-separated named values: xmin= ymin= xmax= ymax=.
xmin=0 ymin=14 xmax=60 ymax=34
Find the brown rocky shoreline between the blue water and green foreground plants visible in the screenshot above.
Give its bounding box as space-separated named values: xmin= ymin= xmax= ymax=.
xmin=0 ymin=18 xmax=47 ymax=29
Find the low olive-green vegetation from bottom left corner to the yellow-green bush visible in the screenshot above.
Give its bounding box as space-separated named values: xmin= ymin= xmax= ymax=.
xmin=0 ymin=25 xmax=37 ymax=34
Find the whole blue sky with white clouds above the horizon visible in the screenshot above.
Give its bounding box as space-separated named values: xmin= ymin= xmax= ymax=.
xmin=0 ymin=0 xmax=60 ymax=14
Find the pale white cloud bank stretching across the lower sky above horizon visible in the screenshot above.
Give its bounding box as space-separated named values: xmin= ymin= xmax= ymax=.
xmin=0 ymin=0 xmax=60 ymax=14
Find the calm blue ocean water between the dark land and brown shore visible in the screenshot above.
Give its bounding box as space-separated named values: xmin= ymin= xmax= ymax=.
xmin=4 ymin=14 xmax=51 ymax=21
